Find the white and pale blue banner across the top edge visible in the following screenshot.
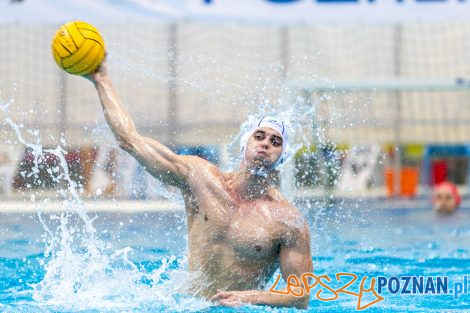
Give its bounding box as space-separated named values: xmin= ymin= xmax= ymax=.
xmin=0 ymin=0 xmax=470 ymax=23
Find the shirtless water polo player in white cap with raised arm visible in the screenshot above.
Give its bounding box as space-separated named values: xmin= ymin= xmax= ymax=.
xmin=87 ymin=59 xmax=313 ymax=308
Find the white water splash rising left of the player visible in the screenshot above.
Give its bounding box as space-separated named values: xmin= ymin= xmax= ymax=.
xmin=0 ymin=91 xmax=211 ymax=311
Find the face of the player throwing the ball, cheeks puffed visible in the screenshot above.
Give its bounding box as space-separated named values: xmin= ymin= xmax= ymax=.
xmin=245 ymin=127 xmax=283 ymax=168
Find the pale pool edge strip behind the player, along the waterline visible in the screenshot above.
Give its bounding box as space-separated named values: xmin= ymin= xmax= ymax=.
xmin=0 ymin=191 xmax=470 ymax=213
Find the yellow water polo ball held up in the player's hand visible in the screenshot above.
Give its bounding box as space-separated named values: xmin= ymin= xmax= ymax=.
xmin=52 ymin=21 xmax=105 ymax=75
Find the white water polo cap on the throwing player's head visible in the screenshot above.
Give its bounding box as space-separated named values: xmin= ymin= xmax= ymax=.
xmin=240 ymin=116 xmax=289 ymax=172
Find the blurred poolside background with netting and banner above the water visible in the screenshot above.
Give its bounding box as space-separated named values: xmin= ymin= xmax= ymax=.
xmin=0 ymin=0 xmax=470 ymax=199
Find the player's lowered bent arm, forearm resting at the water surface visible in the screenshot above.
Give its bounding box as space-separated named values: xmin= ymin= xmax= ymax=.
xmin=211 ymin=213 xmax=313 ymax=309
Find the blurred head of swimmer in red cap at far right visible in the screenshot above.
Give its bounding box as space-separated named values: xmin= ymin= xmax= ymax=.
xmin=432 ymin=182 xmax=462 ymax=215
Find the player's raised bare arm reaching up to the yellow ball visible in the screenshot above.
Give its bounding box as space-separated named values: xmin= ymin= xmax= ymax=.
xmin=87 ymin=63 xmax=190 ymax=188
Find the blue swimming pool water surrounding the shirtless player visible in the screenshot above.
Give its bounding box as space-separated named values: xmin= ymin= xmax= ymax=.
xmin=0 ymin=203 xmax=470 ymax=312
